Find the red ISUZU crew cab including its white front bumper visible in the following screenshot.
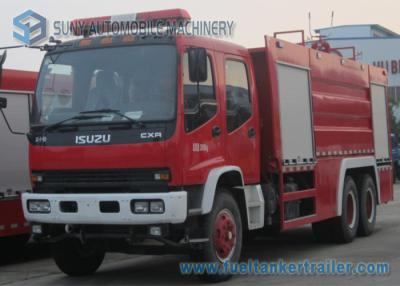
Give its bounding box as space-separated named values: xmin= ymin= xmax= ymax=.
xmin=8 ymin=9 xmax=263 ymax=282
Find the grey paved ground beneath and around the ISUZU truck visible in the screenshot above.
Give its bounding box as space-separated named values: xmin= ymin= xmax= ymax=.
xmin=0 ymin=185 xmax=400 ymax=285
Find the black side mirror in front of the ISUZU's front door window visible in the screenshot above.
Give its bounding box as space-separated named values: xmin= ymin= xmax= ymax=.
xmin=188 ymin=48 xmax=207 ymax=82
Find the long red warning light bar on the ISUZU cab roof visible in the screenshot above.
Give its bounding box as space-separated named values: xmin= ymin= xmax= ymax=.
xmin=71 ymin=9 xmax=191 ymax=37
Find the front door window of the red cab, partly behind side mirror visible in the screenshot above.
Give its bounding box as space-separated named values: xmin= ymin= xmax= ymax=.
xmin=183 ymin=53 xmax=217 ymax=132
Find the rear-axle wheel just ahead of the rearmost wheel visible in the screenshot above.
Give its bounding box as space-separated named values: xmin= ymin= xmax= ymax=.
xmin=332 ymin=176 xmax=360 ymax=243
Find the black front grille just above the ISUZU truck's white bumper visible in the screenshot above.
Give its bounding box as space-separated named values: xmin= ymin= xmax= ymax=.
xmin=33 ymin=169 xmax=168 ymax=193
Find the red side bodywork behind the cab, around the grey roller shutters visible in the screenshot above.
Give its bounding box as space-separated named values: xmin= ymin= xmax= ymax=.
xmin=250 ymin=37 xmax=393 ymax=229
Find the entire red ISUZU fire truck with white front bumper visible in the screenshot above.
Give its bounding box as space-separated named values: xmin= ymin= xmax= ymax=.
xmin=3 ymin=9 xmax=393 ymax=280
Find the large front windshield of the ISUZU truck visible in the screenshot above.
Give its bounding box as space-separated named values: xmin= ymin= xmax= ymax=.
xmin=32 ymin=45 xmax=177 ymax=125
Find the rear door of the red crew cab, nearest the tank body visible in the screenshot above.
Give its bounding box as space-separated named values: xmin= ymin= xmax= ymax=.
xmin=223 ymin=55 xmax=260 ymax=184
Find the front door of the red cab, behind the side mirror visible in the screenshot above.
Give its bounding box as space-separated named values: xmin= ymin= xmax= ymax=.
xmin=181 ymin=48 xmax=225 ymax=185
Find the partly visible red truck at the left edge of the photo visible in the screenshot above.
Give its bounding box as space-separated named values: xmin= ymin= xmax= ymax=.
xmin=0 ymin=64 xmax=37 ymax=247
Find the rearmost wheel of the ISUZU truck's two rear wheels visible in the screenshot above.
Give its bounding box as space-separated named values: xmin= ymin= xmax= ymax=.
xmin=358 ymin=175 xmax=377 ymax=236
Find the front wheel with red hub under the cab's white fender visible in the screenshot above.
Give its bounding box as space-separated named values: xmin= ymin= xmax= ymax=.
xmin=192 ymin=189 xmax=243 ymax=282
